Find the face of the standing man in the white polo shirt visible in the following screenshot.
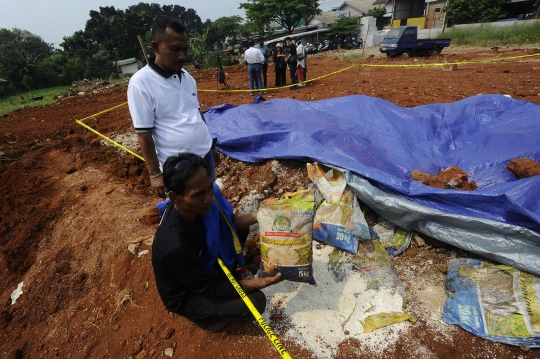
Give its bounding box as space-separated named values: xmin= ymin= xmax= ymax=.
xmin=150 ymin=28 xmax=189 ymax=72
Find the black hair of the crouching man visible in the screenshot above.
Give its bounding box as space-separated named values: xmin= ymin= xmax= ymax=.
xmin=163 ymin=153 xmax=210 ymax=195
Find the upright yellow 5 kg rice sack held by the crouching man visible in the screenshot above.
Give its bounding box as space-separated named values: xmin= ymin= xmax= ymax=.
xmin=257 ymin=190 xmax=316 ymax=284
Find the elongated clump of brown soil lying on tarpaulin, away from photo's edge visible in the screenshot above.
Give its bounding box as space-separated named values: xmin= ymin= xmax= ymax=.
xmin=411 ymin=166 xmax=477 ymax=191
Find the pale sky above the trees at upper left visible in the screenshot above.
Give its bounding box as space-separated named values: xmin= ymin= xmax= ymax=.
xmin=0 ymin=0 xmax=343 ymax=46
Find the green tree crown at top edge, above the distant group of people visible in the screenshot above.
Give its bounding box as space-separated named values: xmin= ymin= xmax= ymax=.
xmin=240 ymin=0 xmax=321 ymax=34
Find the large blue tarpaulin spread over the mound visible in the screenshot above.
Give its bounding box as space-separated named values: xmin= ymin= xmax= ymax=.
xmin=205 ymin=95 xmax=540 ymax=274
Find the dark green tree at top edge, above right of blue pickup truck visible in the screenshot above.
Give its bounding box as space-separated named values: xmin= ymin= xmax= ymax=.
xmin=446 ymin=0 xmax=510 ymax=24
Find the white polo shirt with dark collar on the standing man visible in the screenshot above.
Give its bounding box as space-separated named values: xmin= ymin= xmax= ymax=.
xmin=128 ymin=61 xmax=212 ymax=164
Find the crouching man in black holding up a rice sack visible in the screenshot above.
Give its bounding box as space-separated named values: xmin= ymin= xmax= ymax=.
xmin=152 ymin=153 xmax=281 ymax=332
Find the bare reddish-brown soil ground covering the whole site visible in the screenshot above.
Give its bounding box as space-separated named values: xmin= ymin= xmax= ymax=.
xmin=0 ymin=45 xmax=540 ymax=359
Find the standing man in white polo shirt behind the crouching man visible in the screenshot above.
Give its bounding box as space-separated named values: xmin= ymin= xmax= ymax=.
xmin=127 ymin=16 xmax=215 ymax=198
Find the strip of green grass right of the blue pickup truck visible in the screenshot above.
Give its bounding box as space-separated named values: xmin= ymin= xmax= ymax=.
xmin=438 ymin=21 xmax=540 ymax=47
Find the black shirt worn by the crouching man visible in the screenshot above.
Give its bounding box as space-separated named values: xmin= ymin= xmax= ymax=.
xmin=152 ymin=203 xmax=238 ymax=314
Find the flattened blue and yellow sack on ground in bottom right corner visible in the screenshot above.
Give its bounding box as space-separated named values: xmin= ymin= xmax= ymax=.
xmin=443 ymin=258 xmax=540 ymax=348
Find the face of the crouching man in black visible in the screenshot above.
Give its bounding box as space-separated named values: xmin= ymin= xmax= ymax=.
xmin=173 ymin=167 xmax=214 ymax=215
